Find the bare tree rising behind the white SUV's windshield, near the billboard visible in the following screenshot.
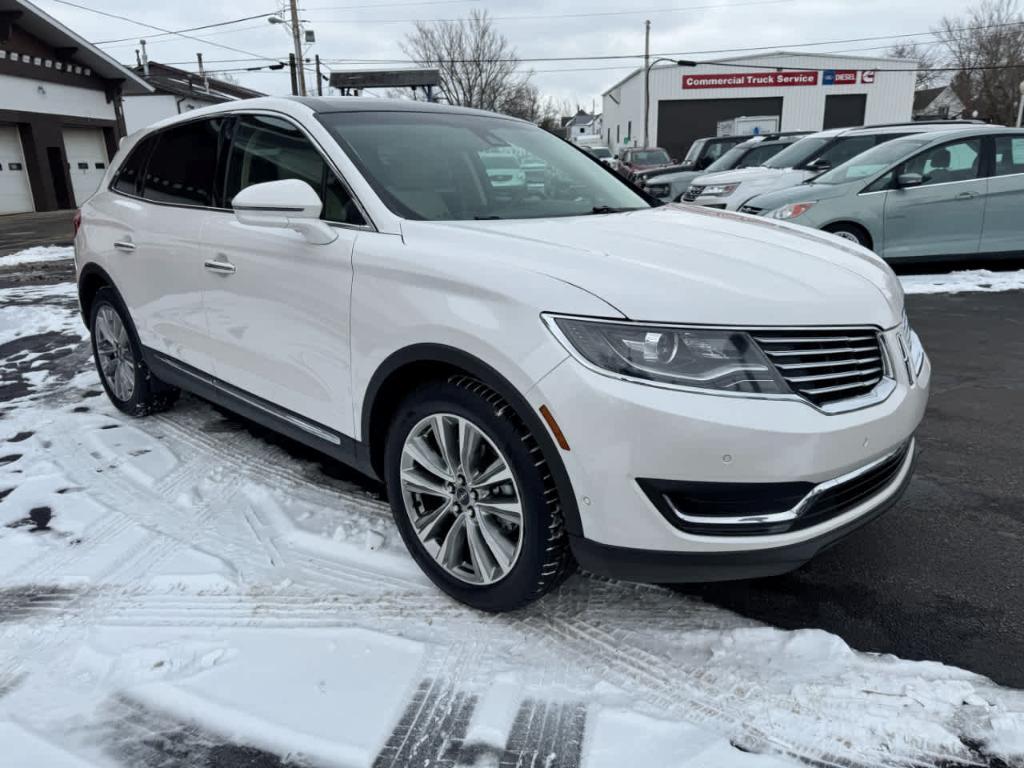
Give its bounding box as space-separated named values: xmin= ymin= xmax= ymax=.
xmin=401 ymin=10 xmax=540 ymax=117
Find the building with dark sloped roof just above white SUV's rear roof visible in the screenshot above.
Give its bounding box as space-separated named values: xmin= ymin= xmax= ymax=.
xmin=125 ymin=61 xmax=266 ymax=133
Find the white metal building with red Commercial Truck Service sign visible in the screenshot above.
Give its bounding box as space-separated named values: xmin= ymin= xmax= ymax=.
xmin=603 ymin=51 xmax=918 ymax=159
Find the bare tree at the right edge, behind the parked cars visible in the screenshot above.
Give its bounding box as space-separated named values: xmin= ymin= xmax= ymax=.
xmin=935 ymin=0 xmax=1024 ymax=125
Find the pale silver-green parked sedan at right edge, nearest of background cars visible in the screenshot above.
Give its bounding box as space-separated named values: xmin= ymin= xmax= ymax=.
xmin=740 ymin=126 xmax=1024 ymax=259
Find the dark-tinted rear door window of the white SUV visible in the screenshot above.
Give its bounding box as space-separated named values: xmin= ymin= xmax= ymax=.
xmin=142 ymin=118 xmax=224 ymax=206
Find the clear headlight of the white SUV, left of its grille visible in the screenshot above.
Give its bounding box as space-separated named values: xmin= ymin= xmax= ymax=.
xmin=554 ymin=317 xmax=790 ymax=394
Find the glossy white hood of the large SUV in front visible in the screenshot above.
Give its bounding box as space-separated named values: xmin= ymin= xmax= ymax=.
xmin=402 ymin=205 xmax=903 ymax=328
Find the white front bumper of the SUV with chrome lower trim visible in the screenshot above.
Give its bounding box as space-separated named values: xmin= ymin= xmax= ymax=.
xmin=528 ymin=331 xmax=931 ymax=581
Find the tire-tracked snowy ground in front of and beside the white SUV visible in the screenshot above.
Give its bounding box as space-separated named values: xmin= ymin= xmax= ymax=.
xmin=0 ymin=272 xmax=1024 ymax=768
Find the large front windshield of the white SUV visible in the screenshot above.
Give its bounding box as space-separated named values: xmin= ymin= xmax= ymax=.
xmin=318 ymin=112 xmax=650 ymax=221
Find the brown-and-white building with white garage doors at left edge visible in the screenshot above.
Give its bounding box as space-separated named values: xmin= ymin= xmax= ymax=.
xmin=0 ymin=0 xmax=152 ymax=214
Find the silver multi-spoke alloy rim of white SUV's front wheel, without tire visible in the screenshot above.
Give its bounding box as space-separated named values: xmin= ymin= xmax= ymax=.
xmin=401 ymin=414 xmax=523 ymax=586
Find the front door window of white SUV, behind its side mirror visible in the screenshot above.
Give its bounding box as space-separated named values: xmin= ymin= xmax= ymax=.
xmin=224 ymin=115 xmax=366 ymax=224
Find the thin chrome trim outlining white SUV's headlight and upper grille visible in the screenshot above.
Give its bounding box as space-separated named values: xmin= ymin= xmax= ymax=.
xmin=541 ymin=312 xmax=896 ymax=416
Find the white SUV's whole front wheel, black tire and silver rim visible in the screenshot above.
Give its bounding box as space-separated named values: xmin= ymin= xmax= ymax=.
xmin=384 ymin=376 xmax=572 ymax=612
